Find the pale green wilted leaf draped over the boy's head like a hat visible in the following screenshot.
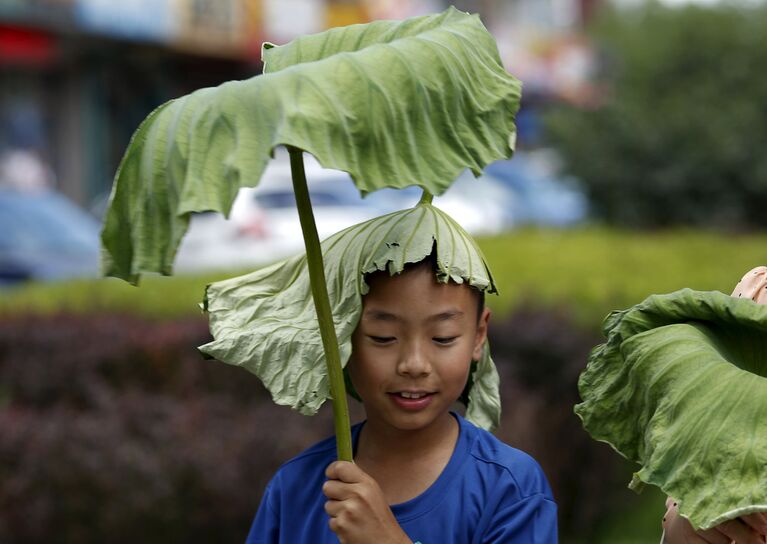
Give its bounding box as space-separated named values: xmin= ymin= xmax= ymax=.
xmin=200 ymin=203 xmax=500 ymax=428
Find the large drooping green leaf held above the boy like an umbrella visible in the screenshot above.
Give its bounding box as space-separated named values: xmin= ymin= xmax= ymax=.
xmin=102 ymin=8 xmax=520 ymax=282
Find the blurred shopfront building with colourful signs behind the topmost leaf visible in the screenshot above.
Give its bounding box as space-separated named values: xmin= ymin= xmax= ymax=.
xmin=0 ymin=0 xmax=597 ymax=206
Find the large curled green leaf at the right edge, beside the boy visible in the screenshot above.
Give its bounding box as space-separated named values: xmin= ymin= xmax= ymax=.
xmin=575 ymin=289 xmax=767 ymax=529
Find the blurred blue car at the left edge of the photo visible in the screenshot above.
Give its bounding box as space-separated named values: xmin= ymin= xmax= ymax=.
xmin=0 ymin=187 xmax=100 ymax=285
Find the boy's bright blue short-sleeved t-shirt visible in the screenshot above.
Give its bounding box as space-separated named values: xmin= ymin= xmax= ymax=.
xmin=247 ymin=414 xmax=557 ymax=544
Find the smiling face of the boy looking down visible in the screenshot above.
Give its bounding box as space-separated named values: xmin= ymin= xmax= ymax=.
xmin=349 ymin=266 xmax=490 ymax=430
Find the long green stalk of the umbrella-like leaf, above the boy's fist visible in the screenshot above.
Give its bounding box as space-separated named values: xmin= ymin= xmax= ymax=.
xmin=288 ymin=146 xmax=353 ymax=461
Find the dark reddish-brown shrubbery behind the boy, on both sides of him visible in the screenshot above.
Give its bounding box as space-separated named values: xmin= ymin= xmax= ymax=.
xmin=0 ymin=307 xmax=644 ymax=544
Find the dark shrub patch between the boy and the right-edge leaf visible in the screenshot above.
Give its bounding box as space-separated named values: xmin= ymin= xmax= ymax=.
xmin=489 ymin=305 xmax=632 ymax=540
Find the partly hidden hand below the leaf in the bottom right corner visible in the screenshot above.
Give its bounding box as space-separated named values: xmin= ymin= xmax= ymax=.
xmin=663 ymin=497 xmax=767 ymax=544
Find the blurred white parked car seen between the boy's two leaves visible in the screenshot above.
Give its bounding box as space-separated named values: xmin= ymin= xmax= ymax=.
xmin=175 ymin=149 xmax=514 ymax=272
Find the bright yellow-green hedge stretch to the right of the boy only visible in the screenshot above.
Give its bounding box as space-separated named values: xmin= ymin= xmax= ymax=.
xmin=480 ymin=228 xmax=767 ymax=327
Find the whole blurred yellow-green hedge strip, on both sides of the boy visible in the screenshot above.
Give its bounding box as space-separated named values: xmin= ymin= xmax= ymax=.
xmin=0 ymin=228 xmax=767 ymax=327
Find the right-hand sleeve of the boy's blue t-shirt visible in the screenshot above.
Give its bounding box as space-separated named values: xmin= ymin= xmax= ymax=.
xmin=481 ymin=493 xmax=557 ymax=544
